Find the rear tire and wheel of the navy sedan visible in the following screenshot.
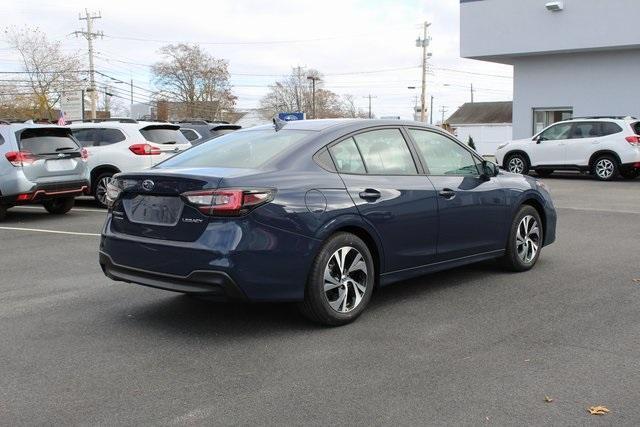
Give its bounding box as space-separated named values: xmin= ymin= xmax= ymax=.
xmin=300 ymin=233 xmax=376 ymax=326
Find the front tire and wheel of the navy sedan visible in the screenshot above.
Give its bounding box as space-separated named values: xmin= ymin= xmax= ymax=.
xmin=500 ymin=205 xmax=544 ymax=271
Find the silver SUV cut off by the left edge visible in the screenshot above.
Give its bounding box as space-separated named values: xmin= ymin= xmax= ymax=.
xmin=0 ymin=122 xmax=89 ymax=220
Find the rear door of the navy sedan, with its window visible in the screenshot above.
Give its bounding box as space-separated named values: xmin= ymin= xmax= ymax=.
xmin=329 ymin=127 xmax=438 ymax=272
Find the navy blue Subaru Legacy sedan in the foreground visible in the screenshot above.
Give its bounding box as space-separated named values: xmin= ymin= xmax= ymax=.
xmin=99 ymin=120 xmax=556 ymax=325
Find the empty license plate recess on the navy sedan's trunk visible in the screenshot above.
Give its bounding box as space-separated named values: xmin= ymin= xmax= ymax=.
xmin=122 ymin=194 xmax=184 ymax=227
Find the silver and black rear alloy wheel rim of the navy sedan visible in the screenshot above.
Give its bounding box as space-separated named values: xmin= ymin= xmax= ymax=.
xmin=324 ymin=246 xmax=367 ymax=313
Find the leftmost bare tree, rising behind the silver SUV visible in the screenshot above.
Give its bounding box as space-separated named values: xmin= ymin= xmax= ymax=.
xmin=5 ymin=27 xmax=81 ymax=119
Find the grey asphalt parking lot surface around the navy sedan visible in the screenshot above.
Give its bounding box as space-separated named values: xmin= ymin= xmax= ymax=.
xmin=0 ymin=175 xmax=640 ymax=425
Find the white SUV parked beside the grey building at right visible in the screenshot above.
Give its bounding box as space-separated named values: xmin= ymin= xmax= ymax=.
xmin=496 ymin=117 xmax=640 ymax=181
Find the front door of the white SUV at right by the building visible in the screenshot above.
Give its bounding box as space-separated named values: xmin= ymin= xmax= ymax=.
xmin=528 ymin=123 xmax=573 ymax=166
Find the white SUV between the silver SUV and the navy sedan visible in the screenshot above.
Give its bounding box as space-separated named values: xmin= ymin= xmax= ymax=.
xmin=69 ymin=119 xmax=191 ymax=207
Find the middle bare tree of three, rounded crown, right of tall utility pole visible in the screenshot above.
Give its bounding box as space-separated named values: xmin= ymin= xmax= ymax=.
xmin=152 ymin=43 xmax=236 ymax=119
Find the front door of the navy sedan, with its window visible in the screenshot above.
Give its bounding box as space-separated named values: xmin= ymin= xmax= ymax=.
xmin=408 ymin=128 xmax=507 ymax=261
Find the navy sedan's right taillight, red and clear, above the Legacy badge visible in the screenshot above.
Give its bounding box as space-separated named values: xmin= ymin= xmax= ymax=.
xmin=182 ymin=188 xmax=274 ymax=216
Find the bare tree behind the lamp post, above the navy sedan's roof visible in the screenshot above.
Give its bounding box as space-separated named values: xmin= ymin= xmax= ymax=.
xmin=260 ymin=67 xmax=360 ymax=118
